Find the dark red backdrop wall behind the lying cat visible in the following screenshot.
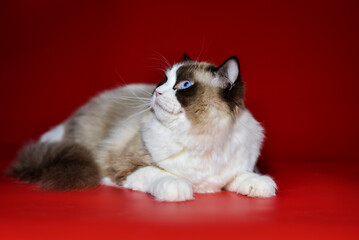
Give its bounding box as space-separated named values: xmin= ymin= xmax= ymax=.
xmin=0 ymin=0 xmax=359 ymax=240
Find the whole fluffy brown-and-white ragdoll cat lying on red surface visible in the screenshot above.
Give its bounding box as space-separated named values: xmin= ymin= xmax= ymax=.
xmin=10 ymin=55 xmax=276 ymax=201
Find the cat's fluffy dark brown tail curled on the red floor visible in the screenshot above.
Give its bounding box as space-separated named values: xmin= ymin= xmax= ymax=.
xmin=8 ymin=142 xmax=101 ymax=191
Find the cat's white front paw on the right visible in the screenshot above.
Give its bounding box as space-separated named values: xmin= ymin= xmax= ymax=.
xmin=225 ymin=172 xmax=277 ymax=197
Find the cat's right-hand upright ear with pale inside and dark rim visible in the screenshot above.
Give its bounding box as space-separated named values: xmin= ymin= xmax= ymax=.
xmin=215 ymin=56 xmax=240 ymax=87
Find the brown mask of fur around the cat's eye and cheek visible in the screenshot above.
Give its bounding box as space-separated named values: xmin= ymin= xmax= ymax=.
xmin=176 ymin=62 xmax=243 ymax=127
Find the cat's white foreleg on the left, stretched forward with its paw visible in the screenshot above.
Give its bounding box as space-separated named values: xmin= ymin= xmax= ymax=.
xmin=122 ymin=166 xmax=193 ymax=202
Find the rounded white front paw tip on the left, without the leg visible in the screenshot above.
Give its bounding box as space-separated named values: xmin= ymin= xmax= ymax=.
xmin=150 ymin=176 xmax=193 ymax=202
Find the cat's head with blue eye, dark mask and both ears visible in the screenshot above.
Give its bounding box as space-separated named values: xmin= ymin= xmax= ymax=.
xmin=151 ymin=54 xmax=244 ymax=132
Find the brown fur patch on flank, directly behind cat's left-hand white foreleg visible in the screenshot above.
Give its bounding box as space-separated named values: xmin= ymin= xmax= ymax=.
xmin=105 ymin=134 xmax=151 ymax=185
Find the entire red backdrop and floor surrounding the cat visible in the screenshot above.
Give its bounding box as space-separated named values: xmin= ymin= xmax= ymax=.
xmin=0 ymin=0 xmax=359 ymax=239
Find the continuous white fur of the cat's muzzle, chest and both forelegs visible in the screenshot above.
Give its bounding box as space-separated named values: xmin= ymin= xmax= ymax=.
xmin=123 ymin=65 xmax=276 ymax=201
